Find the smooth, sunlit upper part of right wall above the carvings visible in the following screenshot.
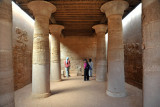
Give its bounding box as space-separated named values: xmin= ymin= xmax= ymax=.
xmin=122 ymin=3 xmax=142 ymax=43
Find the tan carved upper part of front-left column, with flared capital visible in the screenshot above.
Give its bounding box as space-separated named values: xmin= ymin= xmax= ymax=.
xmin=28 ymin=1 xmax=56 ymax=64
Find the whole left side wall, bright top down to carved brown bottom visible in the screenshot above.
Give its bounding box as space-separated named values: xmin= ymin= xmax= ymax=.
xmin=12 ymin=2 xmax=34 ymax=90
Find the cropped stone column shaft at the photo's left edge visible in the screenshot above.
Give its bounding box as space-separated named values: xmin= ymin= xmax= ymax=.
xmin=0 ymin=0 xmax=14 ymax=107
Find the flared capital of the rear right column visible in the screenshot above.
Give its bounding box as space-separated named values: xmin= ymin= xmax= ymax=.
xmin=92 ymin=24 xmax=107 ymax=34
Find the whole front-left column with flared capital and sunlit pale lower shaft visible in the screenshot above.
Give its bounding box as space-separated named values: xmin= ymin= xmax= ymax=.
xmin=28 ymin=1 xmax=56 ymax=98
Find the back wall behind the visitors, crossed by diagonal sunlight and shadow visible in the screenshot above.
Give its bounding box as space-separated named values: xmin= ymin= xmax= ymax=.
xmin=60 ymin=36 xmax=97 ymax=74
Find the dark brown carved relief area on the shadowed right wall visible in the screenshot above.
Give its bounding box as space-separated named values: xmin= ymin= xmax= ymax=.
xmin=124 ymin=43 xmax=143 ymax=88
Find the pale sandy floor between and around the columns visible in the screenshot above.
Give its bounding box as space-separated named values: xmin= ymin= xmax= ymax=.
xmin=15 ymin=76 xmax=142 ymax=107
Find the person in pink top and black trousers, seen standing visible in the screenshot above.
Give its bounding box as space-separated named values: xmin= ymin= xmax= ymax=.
xmin=84 ymin=59 xmax=89 ymax=81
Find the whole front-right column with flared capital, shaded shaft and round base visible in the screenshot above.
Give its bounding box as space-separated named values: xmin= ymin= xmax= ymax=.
xmin=101 ymin=0 xmax=128 ymax=97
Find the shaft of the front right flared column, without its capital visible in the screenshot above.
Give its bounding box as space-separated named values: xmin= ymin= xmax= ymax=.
xmin=107 ymin=15 xmax=126 ymax=97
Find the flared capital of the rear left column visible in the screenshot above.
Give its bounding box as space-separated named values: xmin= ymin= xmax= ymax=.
xmin=49 ymin=24 xmax=64 ymax=36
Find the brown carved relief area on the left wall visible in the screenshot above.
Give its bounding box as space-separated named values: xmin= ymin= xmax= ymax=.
xmin=13 ymin=28 xmax=32 ymax=90
